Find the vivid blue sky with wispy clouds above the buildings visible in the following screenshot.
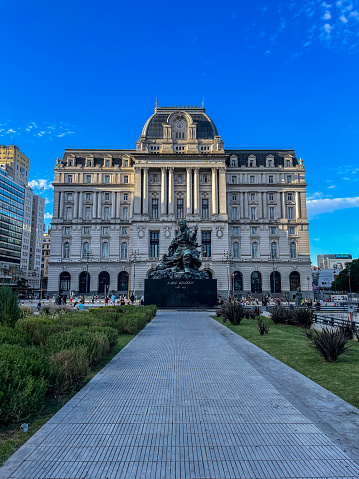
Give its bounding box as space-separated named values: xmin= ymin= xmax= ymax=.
xmin=0 ymin=0 xmax=359 ymax=264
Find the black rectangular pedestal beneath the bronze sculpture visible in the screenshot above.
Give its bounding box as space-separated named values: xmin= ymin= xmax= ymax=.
xmin=144 ymin=279 xmax=217 ymax=308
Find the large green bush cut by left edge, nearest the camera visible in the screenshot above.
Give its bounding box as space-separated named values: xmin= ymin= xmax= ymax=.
xmin=0 ymin=344 xmax=50 ymax=424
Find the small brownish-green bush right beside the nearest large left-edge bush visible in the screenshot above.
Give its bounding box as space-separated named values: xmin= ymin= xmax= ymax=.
xmin=50 ymin=348 xmax=89 ymax=394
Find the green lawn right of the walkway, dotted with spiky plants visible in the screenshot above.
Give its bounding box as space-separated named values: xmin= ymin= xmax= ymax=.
xmin=215 ymin=318 xmax=359 ymax=408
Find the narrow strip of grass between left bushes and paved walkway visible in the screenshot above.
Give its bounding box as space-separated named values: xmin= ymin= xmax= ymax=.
xmin=0 ymin=334 xmax=135 ymax=466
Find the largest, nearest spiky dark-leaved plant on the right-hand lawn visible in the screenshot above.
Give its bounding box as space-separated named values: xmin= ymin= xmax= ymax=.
xmin=305 ymin=328 xmax=348 ymax=363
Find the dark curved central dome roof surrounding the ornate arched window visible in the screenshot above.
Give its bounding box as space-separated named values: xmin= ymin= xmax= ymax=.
xmin=142 ymin=105 xmax=218 ymax=139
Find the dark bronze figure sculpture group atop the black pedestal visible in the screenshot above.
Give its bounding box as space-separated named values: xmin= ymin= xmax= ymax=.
xmin=150 ymin=220 xmax=209 ymax=279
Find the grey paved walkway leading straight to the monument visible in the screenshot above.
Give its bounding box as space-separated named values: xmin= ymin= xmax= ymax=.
xmin=0 ymin=312 xmax=359 ymax=479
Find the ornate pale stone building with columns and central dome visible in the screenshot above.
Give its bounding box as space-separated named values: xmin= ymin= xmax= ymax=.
xmin=48 ymin=106 xmax=311 ymax=296
